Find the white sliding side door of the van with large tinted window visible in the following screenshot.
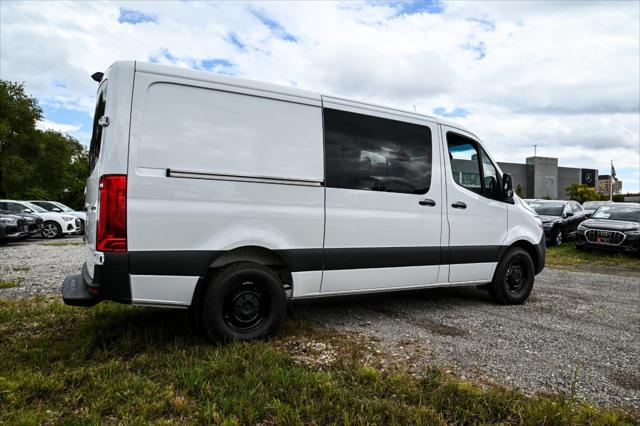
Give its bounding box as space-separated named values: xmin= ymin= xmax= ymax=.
xmin=321 ymin=98 xmax=442 ymax=293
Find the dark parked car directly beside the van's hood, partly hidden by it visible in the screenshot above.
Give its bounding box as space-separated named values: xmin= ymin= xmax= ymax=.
xmin=530 ymin=200 xmax=585 ymax=246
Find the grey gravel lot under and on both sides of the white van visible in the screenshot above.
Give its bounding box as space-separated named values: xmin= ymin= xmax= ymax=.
xmin=0 ymin=237 xmax=640 ymax=408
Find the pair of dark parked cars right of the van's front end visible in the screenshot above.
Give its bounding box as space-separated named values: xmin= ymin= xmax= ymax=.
xmin=524 ymin=199 xmax=640 ymax=255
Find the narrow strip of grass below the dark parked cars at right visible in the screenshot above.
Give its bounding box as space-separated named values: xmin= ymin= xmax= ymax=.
xmin=546 ymin=243 xmax=640 ymax=271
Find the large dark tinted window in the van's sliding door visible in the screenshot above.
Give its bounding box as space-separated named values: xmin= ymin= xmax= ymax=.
xmin=324 ymin=108 xmax=432 ymax=194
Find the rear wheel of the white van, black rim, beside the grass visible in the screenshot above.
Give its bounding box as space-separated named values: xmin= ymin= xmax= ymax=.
xmin=202 ymin=262 xmax=287 ymax=341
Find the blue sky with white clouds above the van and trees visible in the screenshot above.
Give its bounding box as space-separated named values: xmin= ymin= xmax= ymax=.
xmin=0 ymin=0 xmax=640 ymax=192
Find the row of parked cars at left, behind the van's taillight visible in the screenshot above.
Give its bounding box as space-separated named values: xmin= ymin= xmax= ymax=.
xmin=0 ymin=200 xmax=87 ymax=243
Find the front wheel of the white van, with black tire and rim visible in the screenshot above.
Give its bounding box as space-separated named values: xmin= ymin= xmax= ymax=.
xmin=489 ymin=247 xmax=535 ymax=305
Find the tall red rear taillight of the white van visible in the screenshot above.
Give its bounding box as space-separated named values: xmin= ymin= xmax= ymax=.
xmin=96 ymin=175 xmax=127 ymax=251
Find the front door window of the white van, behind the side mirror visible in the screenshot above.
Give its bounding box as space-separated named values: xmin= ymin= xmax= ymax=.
xmin=447 ymin=133 xmax=482 ymax=194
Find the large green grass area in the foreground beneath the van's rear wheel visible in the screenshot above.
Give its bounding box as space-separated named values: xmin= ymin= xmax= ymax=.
xmin=0 ymin=298 xmax=639 ymax=425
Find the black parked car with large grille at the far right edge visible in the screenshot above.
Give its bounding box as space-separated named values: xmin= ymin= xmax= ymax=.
xmin=576 ymin=203 xmax=640 ymax=255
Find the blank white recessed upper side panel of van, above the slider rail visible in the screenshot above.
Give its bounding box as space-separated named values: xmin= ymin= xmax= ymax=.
xmin=136 ymin=83 xmax=323 ymax=181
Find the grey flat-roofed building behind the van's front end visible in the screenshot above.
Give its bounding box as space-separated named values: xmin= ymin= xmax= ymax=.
xmin=498 ymin=157 xmax=598 ymax=200
